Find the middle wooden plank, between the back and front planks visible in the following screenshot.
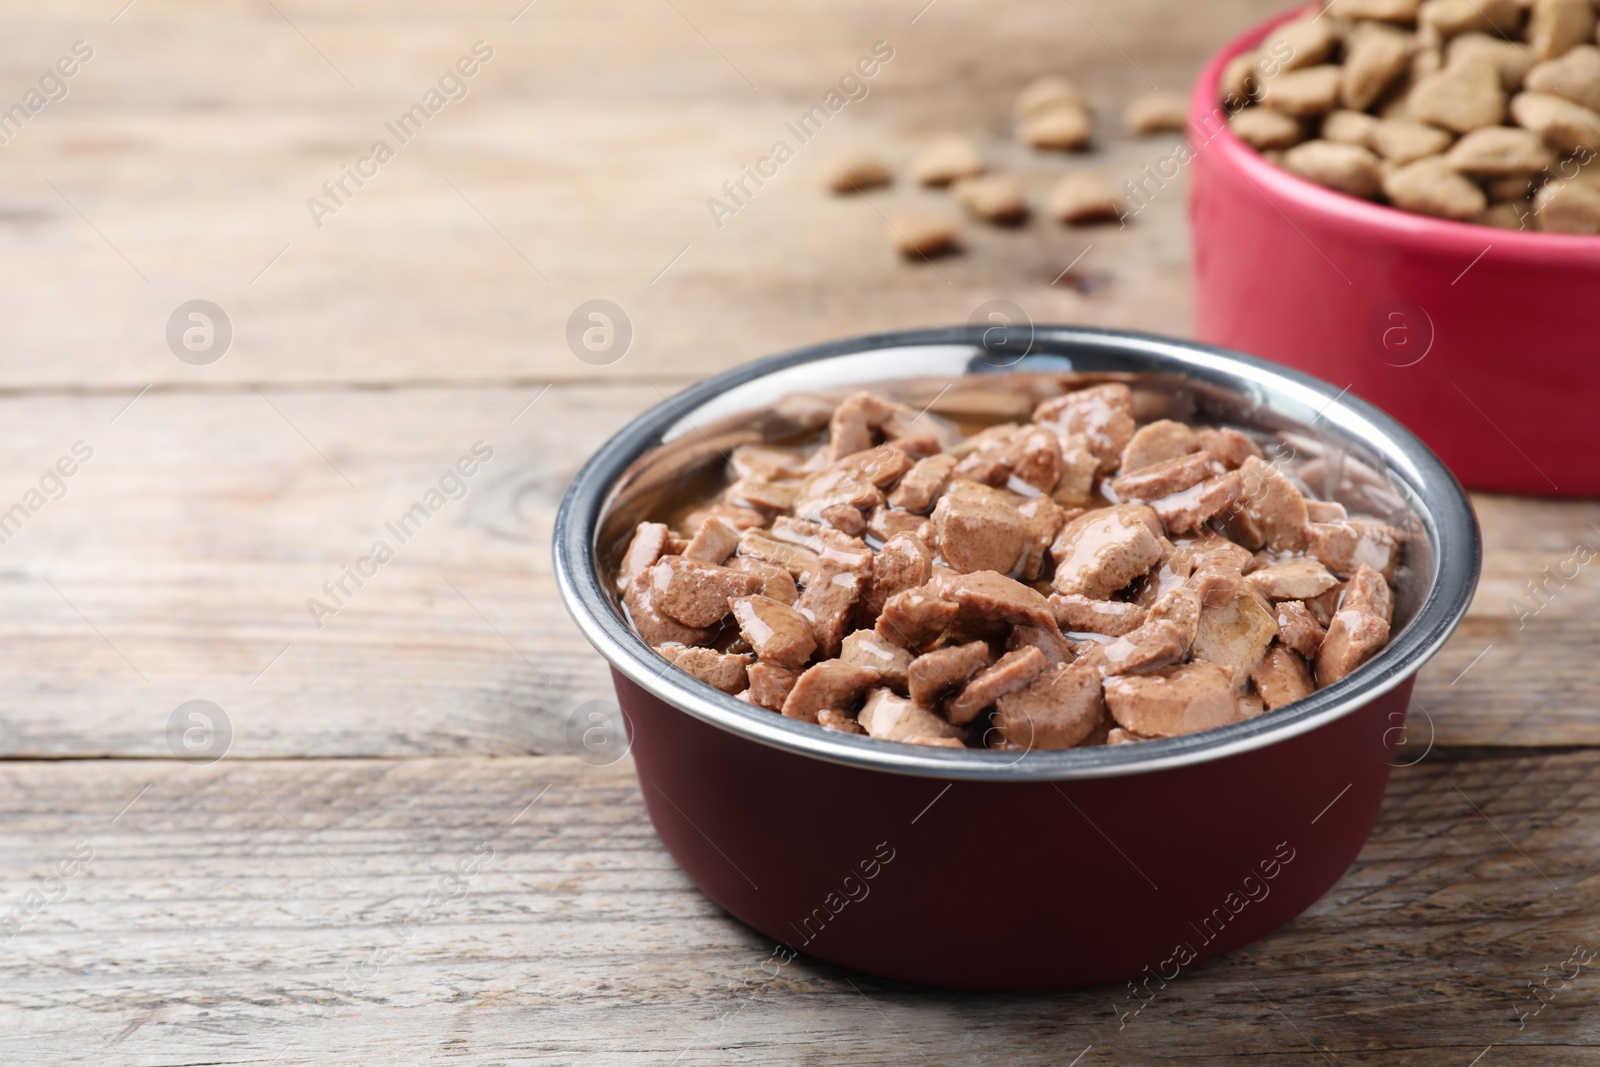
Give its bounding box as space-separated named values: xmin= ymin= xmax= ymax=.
xmin=0 ymin=384 xmax=1600 ymax=757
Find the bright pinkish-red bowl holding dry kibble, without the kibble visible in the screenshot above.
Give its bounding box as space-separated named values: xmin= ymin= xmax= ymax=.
xmin=1190 ymin=8 xmax=1600 ymax=496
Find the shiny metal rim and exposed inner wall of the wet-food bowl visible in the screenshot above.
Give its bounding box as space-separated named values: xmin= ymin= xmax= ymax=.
xmin=554 ymin=326 xmax=1482 ymax=781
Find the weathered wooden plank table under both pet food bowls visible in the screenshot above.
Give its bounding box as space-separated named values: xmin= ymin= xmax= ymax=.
xmin=0 ymin=0 xmax=1600 ymax=1067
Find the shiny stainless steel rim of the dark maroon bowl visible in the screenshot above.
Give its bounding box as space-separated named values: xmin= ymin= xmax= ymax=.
xmin=552 ymin=325 xmax=1482 ymax=781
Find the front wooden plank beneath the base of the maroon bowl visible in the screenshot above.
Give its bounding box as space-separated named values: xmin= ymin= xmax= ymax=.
xmin=0 ymin=752 xmax=1600 ymax=1067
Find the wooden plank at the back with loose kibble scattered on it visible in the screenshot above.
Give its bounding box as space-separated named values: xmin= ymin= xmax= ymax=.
xmin=0 ymin=0 xmax=1282 ymax=390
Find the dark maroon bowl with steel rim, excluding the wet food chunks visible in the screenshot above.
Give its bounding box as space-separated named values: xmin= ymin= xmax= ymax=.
xmin=554 ymin=326 xmax=1480 ymax=990
